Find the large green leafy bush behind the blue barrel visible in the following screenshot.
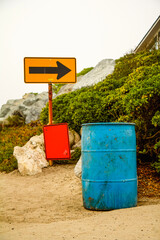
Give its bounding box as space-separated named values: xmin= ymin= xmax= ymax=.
xmin=41 ymin=50 xmax=160 ymax=172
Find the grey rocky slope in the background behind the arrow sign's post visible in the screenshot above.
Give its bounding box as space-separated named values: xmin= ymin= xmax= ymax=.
xmin=0 ymin=59 xmax=115 ymax=124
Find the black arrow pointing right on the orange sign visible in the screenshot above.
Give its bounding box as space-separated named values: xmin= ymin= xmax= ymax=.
xmin=29 ymin=61 xmax=71 ymax=79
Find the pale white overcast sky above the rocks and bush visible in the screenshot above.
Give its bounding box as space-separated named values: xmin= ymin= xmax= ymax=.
xmin=0 ymin=0 xmax=160 ymax=107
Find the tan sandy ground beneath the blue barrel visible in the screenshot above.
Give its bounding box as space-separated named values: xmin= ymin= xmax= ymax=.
xmin=0 ymin=164 xmax=160 ymax=240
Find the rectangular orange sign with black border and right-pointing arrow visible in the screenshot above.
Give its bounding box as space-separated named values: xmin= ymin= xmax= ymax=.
xmin=24 ymin=57 xmax=76 ymax=83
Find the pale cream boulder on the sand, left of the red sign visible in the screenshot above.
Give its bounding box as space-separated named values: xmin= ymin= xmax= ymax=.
xmin=13 ymin=134 xmax=48 ymax=176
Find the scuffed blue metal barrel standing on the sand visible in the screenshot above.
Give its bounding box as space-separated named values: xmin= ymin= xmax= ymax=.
xmin=82 ymin=123 xmax=137 ymax=210
